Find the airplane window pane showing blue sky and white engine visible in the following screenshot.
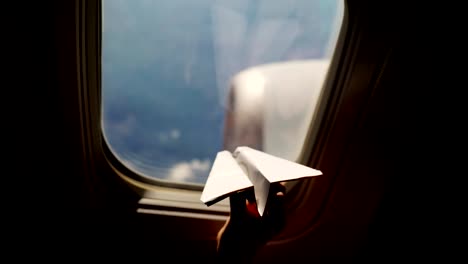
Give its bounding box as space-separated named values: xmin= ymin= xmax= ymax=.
xmin=102 ymin=0 xmax=343 ymax=184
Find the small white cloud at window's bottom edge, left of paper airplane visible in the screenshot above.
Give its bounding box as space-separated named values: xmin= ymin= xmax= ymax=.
xmin=167 ymin=159 xmax=211 ymax=182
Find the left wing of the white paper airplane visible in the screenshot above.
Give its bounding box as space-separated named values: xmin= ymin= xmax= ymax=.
xmin=200 ymin=150 xmax=253 ymax=206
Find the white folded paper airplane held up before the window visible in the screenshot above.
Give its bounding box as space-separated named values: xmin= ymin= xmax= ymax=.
xmin=200 ymin=146 xmax=322 ymax=216
